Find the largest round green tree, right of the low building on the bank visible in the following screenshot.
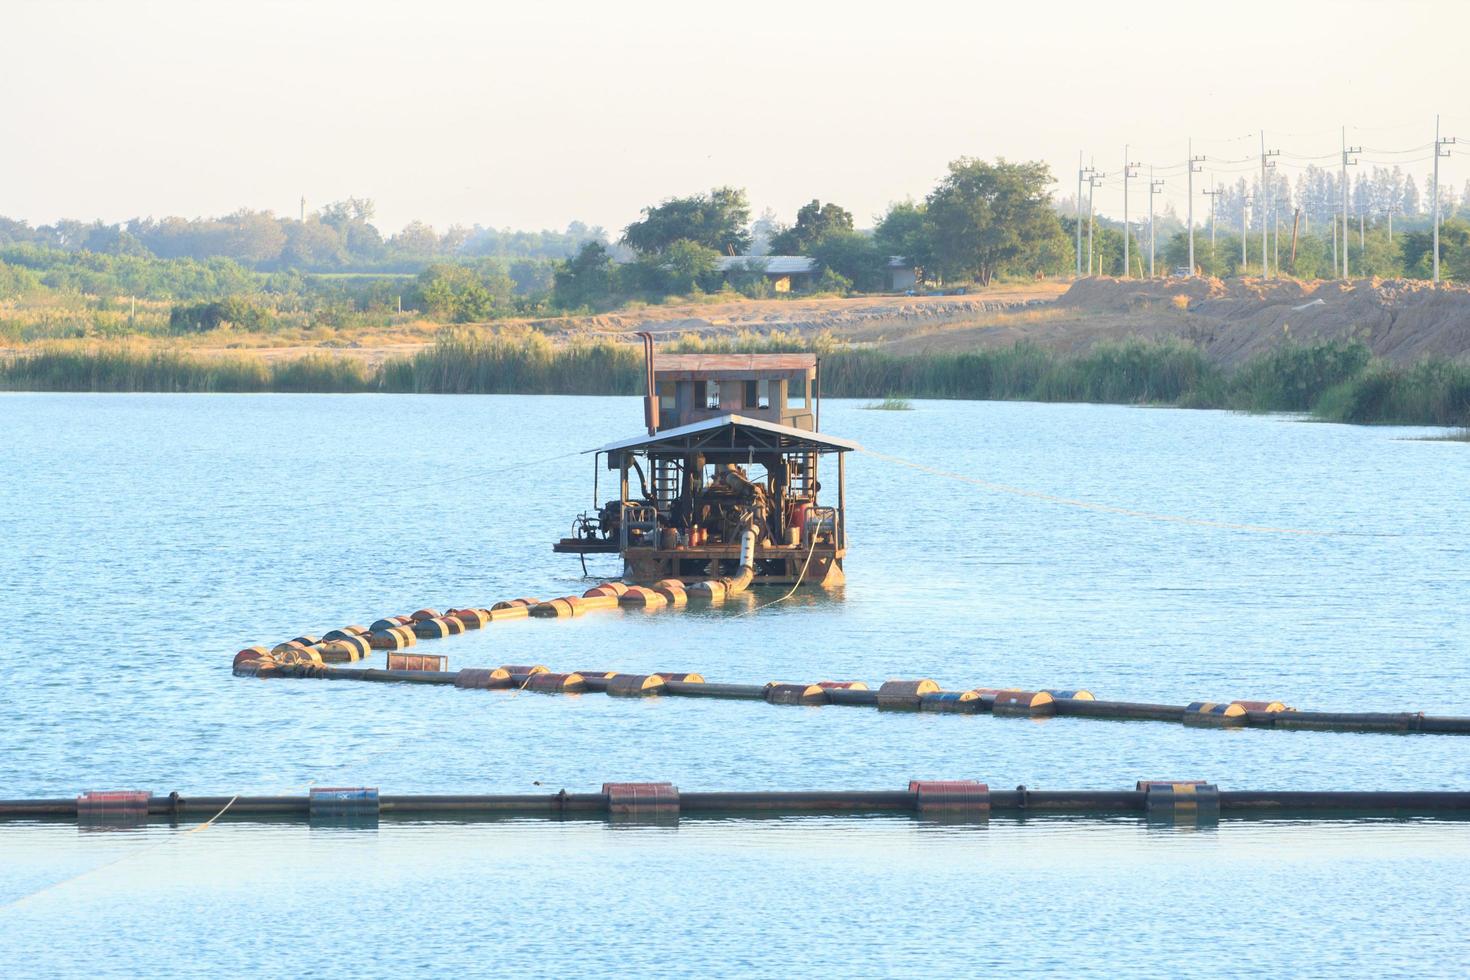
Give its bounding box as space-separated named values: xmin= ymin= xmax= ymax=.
xmin=928 ymin=157 xmax=1061 ymax=287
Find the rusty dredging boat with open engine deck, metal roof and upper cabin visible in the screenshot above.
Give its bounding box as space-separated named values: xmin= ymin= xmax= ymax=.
xmin=554 ymin=346 xmax=858 ymax=586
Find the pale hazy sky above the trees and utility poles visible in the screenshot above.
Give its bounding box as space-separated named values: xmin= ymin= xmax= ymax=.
xmin=0 ymin=0 xmax=1470 ymax=231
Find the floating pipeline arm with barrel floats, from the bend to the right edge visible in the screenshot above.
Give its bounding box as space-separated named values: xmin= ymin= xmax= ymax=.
xmin=234 ymin=646 xmax=1470 ymax=735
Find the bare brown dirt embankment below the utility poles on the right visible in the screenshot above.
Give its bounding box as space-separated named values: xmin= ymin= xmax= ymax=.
xmin=1055 ymin=279 xmax=1470 ymax=364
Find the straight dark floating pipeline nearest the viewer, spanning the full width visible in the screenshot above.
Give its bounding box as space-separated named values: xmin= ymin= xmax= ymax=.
xmin=0 ymin=779 xmax=1470 ymax=829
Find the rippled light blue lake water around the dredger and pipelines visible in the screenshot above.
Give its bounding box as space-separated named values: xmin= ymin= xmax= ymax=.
xmin=0 ymin=395 xmax=1470 ymax=976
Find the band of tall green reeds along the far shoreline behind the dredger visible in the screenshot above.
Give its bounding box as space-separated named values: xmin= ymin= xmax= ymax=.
xmin=0 ymin=329 xmax=1470 ymax=426
